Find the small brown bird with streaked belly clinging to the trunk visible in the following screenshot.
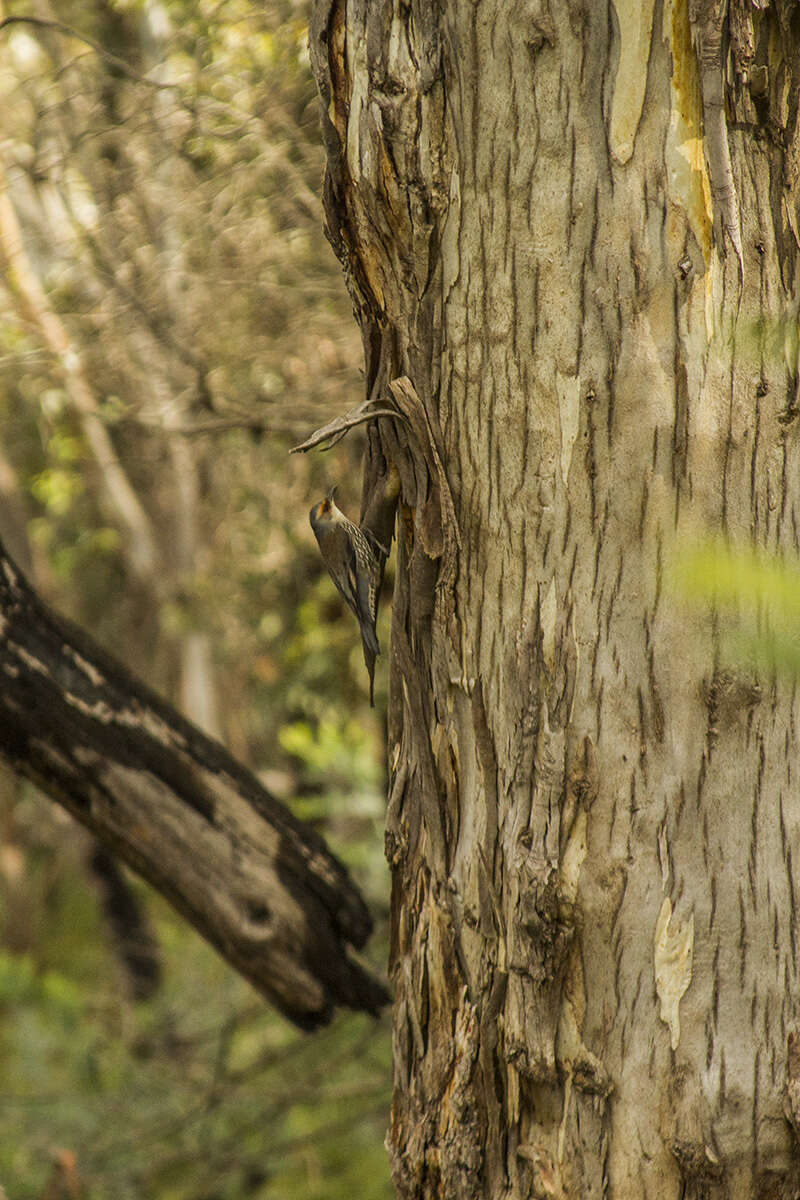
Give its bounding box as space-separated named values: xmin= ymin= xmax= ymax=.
xmin=308 ymin=487 xmax=387 ymax=706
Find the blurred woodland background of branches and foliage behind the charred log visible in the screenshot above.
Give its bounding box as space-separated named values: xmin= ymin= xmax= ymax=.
xmin=0 ymin=0 xmax=391 ymax=1200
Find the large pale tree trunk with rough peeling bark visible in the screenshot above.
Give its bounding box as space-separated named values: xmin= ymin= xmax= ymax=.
xmin=311 ymin=0 xmax=800 ymax=1200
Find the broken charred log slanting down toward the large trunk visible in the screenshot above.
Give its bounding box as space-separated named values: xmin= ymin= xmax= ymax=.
xmin=0 ymin=547 xmax=387 ymax=1028
